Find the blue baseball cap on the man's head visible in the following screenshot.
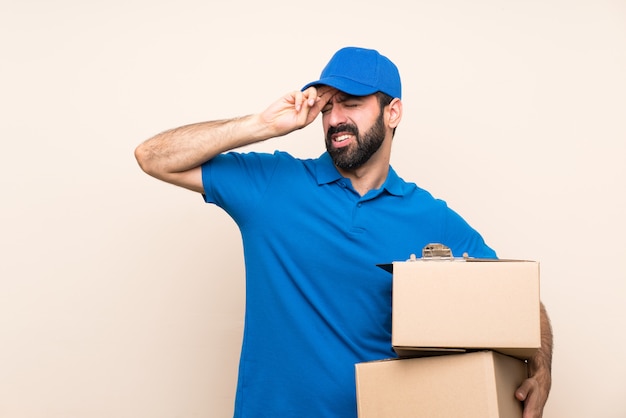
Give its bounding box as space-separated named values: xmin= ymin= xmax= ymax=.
xmin=302 ymin=46 xmax=402 ymax=98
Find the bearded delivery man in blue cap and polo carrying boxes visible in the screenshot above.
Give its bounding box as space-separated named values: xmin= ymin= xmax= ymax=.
xmin=135 ymin=47 xmax=551 ymax=418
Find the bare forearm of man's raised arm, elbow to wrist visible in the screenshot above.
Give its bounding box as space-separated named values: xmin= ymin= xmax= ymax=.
xmin=135 ymin=115 xmax=269 ymax=180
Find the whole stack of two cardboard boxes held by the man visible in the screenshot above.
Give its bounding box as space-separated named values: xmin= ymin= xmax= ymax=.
xmin=356 ymin=253 xmax=541 ymax=418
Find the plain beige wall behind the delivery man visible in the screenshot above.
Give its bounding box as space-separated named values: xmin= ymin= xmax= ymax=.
xmin=0 ymin=0 xmax=626 ymax=418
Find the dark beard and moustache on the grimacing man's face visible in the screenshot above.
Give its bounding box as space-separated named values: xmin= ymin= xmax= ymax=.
xmin=326 ymin=111 xmax=385 ymax=170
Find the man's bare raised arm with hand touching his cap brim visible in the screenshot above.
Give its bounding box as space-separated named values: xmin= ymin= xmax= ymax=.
xmin=135 ymin=87 xmax=330 ymax=193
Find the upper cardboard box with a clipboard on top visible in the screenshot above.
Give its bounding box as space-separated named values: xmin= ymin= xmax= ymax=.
xmin=391 ymin=259 xmax=541 ymax=359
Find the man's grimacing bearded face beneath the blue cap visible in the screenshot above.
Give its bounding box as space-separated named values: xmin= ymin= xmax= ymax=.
xmin=322 ymin=92 xmax=385 ymax=170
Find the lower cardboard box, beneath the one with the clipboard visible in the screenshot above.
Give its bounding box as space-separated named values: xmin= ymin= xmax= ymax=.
xmin=356 ymin=351 xmax=527 ymax=418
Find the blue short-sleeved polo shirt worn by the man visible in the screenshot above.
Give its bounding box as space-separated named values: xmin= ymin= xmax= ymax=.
xmin=202 ymin=152 xmax=495 ymax=418
